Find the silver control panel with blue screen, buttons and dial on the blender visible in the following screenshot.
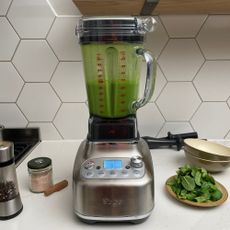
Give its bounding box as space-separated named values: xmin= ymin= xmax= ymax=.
xmin=80 ymin=156 xmax=145 ymax=179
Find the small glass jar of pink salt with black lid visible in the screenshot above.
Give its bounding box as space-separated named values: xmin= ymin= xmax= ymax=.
xmin=27 ymin=157 xmax=53 ymax=193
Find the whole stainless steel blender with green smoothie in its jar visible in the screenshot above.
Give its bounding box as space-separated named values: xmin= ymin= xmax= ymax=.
xmin=73 ymin=17 xmax=156 ymax=223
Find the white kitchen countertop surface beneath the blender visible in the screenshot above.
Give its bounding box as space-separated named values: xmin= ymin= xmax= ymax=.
xmin=0 ymin=141 xmax=230 ymax=230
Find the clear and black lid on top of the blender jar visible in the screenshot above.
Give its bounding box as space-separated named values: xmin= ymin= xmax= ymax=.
xmin=76 ymin=16 xmax=156 ymax=43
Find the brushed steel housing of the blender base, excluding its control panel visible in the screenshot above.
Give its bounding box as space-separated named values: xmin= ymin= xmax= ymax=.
xmin=73 ymin=139 xmax=154 ymax=221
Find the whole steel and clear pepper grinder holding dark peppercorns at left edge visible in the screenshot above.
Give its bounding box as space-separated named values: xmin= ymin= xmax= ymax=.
xmin=0 ymin=141 xmax=23 ymax=220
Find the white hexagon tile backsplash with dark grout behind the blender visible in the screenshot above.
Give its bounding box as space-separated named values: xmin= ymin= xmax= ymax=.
xmin=0 ymin=0 xmax=230 ymax=140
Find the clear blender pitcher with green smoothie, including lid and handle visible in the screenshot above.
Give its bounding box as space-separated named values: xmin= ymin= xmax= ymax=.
xmin=76 ymin=17 xmax=156 ymax=118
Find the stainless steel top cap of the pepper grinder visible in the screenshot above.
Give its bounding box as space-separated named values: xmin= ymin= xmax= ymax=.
xmin=0 ymin=141 xmax=14 ymax=163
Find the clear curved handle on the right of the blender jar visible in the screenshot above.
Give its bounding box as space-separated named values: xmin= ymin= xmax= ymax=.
xmin=132 ymin=48 xmax=156 ymax=111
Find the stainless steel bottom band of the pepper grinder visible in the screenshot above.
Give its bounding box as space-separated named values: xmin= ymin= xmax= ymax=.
xmin=0 ymin=194 xmax=23 ymax=219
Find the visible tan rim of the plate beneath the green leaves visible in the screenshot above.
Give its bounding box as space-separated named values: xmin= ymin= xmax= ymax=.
xmin=165 ymin=176 xmax=228 ymax=208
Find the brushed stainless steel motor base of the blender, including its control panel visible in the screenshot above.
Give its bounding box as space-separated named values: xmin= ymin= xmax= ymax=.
xmin=73 ymin=139 xmax=154 ymax=223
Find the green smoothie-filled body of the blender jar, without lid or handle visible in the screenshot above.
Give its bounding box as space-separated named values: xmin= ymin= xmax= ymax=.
xmin=82 ymin=43 xmax=141 ymax=118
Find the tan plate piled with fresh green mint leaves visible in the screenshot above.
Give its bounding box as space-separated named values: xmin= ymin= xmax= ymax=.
xmin=166 ymin=164 xmax=228 ymax=207
